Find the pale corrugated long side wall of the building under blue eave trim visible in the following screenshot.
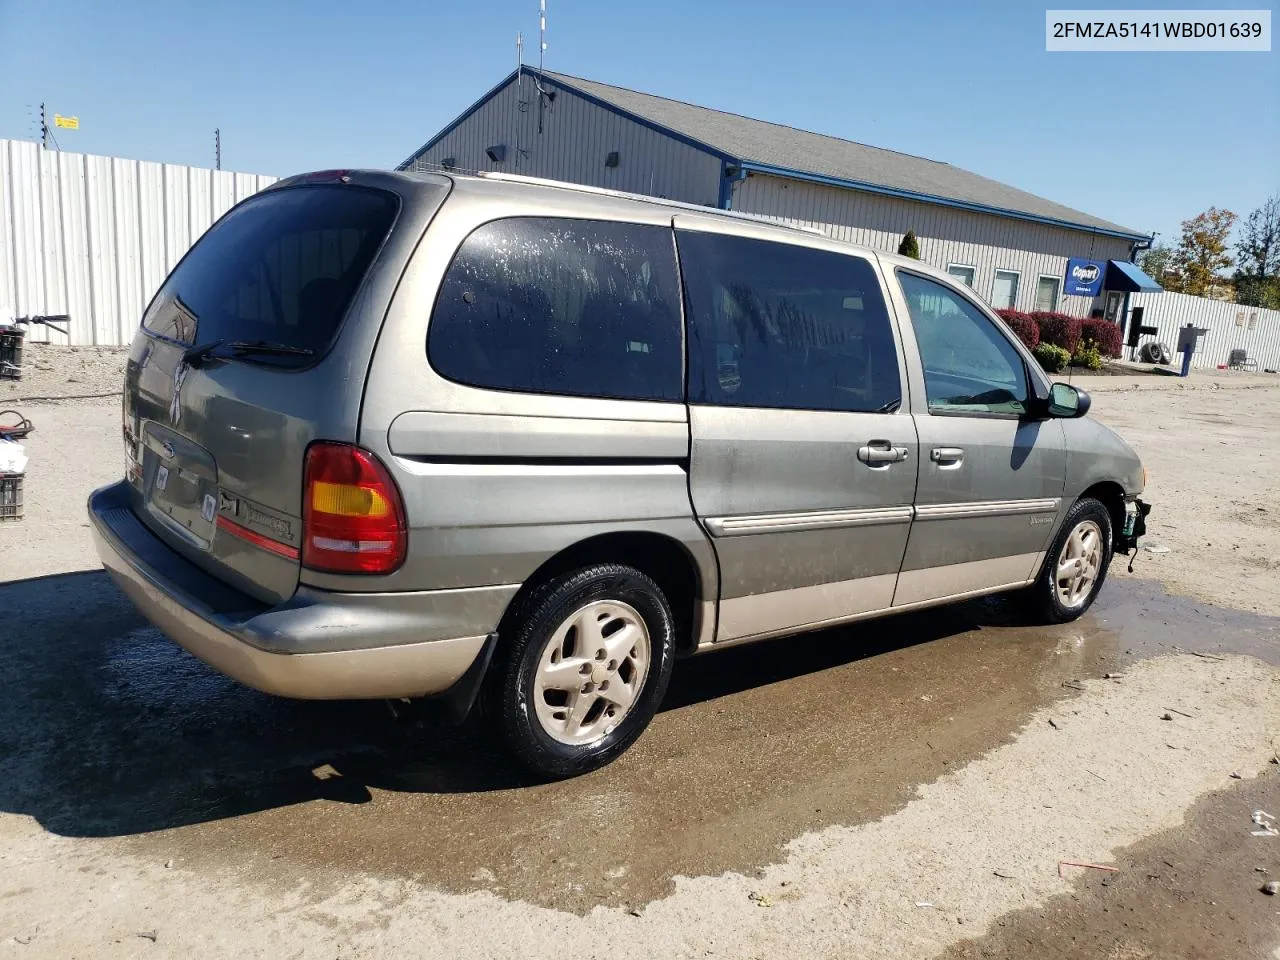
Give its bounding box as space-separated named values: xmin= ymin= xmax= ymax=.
xmin=732 ymin=174 xmax=1129 ymax=316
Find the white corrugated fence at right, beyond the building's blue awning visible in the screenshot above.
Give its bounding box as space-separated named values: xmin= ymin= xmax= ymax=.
xmin=1129 ymin=293 xmax=1280 ymax=370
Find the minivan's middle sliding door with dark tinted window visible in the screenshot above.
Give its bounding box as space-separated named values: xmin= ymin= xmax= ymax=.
xmin=676 ymin=216 xmax=919 ymax=641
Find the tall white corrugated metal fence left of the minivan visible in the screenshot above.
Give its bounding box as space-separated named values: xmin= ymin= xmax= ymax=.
xmin=0 ymin=140 xmax=276 ymax=346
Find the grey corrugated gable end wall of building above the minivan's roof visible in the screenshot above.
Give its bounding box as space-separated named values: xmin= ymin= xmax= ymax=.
xmin=410 ymin=77 xmax=721 ymax=206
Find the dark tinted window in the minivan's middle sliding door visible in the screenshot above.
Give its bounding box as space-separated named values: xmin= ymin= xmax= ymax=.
xmin=677 ymin=230 xmax=902 ymax=413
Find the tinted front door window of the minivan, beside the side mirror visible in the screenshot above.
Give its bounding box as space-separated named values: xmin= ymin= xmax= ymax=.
xmin=899 ymin=273 xmax=1027 ymax=413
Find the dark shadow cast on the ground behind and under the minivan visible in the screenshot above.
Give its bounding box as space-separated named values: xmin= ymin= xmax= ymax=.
xmin=0 ymin=571 xmax=1007 ymax=837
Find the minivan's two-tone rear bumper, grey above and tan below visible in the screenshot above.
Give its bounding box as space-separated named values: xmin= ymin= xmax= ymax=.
xmin=88 ymin=483 xmax=518 ymax=700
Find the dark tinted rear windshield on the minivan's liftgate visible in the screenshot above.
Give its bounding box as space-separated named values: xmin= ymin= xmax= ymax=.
xmin=142 ymin=184 xmax=399 ymax=364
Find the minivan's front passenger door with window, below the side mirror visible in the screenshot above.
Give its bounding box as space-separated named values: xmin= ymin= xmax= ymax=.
xmin=893 ymin=270 xmax=1065 ymax=607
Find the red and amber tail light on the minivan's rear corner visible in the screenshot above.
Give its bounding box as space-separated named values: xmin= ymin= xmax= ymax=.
xmin=302 ymin=443 xmax=408 ymax=573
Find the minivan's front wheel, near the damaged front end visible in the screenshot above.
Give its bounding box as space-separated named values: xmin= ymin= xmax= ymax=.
xmin=1020 ymin=497 xmax=1112 ymax=623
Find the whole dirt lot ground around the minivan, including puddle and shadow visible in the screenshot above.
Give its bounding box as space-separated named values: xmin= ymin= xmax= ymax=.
xmin=0 ymin=353 xmax=1280 ymax=960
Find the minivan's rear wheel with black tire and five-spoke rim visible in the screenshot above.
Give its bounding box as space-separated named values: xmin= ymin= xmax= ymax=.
xmin=489 ymin=563 xmax=676 ymax=780
